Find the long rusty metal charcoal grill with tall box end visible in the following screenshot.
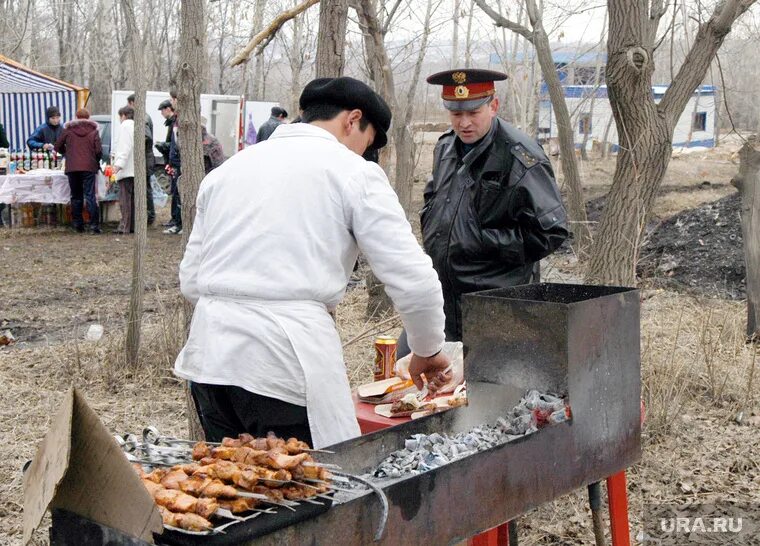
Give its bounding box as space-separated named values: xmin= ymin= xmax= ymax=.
xmin=51 ymin=283 xmax=641 ymax=545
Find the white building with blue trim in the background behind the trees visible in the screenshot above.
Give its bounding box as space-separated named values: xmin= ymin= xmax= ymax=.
xmin=538 ymin=84 xmax=718 ymax=148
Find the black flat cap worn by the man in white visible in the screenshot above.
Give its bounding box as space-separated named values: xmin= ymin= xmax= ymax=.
xmin=298 ymin=76 xmax=391 ymax=150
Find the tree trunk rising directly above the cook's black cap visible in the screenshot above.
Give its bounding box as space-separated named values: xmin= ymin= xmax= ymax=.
xmin=315 ymin=0 xmax=348 ymax=78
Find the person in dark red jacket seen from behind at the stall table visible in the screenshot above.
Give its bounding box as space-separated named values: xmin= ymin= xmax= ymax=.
xmin=55 ymin=108 xmax=103 ymax=234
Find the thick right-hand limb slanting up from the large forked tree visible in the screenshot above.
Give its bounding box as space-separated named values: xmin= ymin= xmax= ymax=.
xmin=658 ymin=0 xmax=757 ymax=119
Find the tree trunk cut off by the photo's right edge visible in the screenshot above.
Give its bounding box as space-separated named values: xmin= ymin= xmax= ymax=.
xmin=731 ymin=137 xmax=760 ymax=341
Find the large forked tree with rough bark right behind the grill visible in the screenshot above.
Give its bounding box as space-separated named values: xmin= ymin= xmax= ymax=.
xmin=586 ymin=0 xmax=755 ymax=286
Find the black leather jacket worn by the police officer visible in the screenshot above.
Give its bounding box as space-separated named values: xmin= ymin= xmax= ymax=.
xmin=420 ymin=118 xmax=569 ymax=341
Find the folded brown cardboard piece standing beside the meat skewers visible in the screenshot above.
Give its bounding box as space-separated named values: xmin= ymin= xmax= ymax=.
xmin=24 ymin=388 xmax=163 ymax=544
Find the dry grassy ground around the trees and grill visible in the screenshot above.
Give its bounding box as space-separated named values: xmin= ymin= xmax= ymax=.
xmin=0 ymin=134 xmax=760 ymax=545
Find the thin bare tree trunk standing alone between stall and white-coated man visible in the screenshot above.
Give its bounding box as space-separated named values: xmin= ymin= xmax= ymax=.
xmin=121 ymin=0 xmax=148 ymax=367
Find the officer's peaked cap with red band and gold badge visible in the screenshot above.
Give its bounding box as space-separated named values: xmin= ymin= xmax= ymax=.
xmin=427 ymin=68 xmax=507 ymax=112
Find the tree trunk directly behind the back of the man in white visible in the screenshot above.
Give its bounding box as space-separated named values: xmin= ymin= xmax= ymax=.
xmin=178 ymin=0 xmax=207 ymax=440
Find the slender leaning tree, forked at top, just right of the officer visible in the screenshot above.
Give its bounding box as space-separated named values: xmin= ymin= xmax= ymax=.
xmin=474 ymin=0 xmax=591 ymax=257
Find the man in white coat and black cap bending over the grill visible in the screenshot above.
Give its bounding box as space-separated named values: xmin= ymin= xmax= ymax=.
xmin=174 ymin=77 xmax=450 ymax=448
